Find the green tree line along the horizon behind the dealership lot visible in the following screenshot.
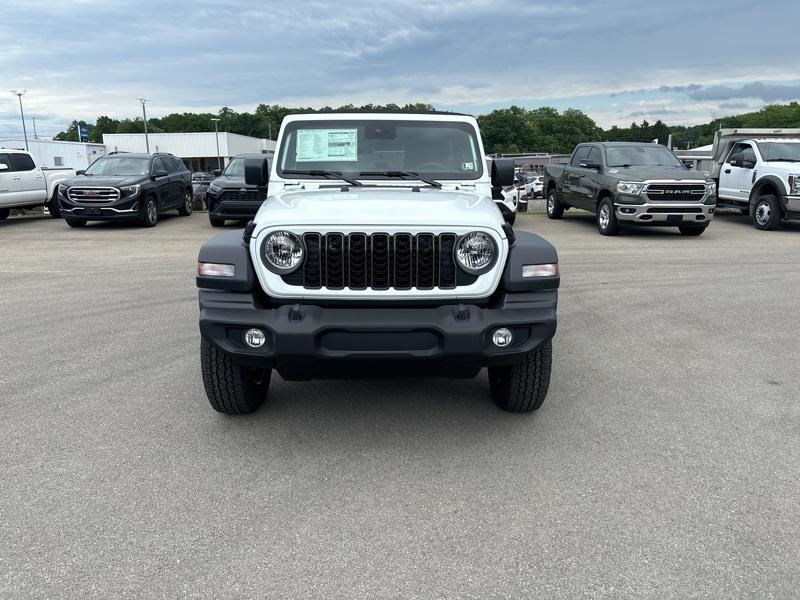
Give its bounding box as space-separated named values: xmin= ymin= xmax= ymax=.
xmin=55 ymin=102 xmax=800 ymax=154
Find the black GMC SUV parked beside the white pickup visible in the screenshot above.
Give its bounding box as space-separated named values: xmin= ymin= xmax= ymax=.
xmin=58 ymin=152 xmax=192 ymax=227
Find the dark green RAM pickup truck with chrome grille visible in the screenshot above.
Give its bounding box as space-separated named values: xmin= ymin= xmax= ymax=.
xmin=544 ymin=142 xmax=717 ymax=236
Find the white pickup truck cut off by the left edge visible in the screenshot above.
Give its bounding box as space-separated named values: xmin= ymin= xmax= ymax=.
xmin=0 ymin=148 xmax=75 ymax=221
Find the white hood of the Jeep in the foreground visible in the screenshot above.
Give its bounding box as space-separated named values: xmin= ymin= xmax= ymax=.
xmin=256 ymin=187 xmax=505 ymax=232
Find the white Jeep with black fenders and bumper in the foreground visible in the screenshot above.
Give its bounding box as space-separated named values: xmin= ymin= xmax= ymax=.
xmin=197 ymin=113 xmax=560 ymax=414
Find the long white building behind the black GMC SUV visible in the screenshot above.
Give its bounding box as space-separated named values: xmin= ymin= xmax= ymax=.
xmin=103 ymin=131 xmax=275 ymax=171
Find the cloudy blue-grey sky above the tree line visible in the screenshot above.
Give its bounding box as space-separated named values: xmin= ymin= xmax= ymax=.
xmin=0 ymin=0 xmax=800 ymax=138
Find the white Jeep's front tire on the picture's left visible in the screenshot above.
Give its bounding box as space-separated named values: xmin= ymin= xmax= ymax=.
xmin=200 ymin=338 xmax=272 ymax=415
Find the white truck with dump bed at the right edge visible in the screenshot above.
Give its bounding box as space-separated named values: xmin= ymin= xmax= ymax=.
xmin=711 ymin=129 xmax=800 ymax=230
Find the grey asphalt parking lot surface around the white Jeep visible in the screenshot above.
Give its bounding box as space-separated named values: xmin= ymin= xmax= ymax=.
xmin=0 ymin=213 xmax=800 ymax=599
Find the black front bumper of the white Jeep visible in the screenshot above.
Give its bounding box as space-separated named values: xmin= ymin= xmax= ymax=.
xmin=200 ymin=289 xmax=558 ymax=380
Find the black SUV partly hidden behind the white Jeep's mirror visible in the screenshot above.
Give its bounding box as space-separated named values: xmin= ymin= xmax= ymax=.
xmin=206 ymin=154 xmax=272 ymax=227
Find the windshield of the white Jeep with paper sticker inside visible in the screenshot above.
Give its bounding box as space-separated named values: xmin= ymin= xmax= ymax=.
xmin=277 ymin=119 xmax=483 ymax=180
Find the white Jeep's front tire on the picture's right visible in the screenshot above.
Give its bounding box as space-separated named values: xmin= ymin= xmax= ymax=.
xmin=489 ymin=340 xmax=553 ymax=412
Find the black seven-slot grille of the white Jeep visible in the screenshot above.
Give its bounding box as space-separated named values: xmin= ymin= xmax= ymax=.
xmin=283 ymin=233 xmax=478 ymax=290
